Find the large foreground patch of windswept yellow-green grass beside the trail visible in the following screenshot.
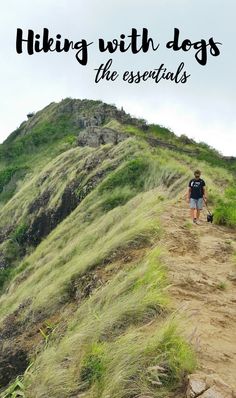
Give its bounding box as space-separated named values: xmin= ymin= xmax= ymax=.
xmin=21 ymin=249 xmax=196 ymax=398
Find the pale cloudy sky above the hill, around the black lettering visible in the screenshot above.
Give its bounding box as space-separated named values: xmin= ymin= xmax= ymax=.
xmin=0 ymin=0 xmax=236 ymax=156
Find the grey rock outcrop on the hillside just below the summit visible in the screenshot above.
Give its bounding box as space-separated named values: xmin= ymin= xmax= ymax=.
xmin=78 ymin=127 xmax=129 ymax=147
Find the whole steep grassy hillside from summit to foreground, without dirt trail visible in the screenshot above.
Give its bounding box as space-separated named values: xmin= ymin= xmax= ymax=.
xmin=0 ymin=99 xmax=236 ymax=398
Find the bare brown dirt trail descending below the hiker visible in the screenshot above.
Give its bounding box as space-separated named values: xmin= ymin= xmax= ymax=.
xmin=161 ymin=200 xmax=236 ymax=391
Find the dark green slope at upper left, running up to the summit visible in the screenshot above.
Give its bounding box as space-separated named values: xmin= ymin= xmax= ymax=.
xmin=0 ymin=98 xmax=136 ymax=202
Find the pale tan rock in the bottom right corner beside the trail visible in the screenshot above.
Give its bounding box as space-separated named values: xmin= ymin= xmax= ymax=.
xmin=186 ymin=373 xmax=236 ymax=398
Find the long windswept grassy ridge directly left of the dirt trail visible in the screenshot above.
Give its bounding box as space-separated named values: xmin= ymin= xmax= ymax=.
xmin=0 ymin=139 xmax=195 ymax=398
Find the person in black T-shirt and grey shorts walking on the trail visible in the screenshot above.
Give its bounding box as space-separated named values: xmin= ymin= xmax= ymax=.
xmin=187 ymin=170 xmax=207 ymax=224
